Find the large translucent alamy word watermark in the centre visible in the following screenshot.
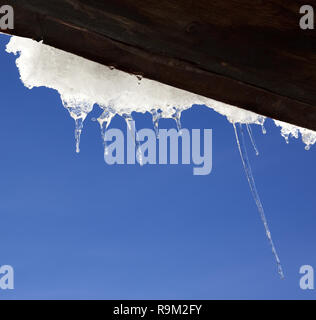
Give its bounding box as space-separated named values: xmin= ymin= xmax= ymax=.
xmin=104 ymin=121 xmax=212 ymax=175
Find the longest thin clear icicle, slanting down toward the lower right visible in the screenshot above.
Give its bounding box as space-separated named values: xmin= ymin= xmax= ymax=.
xmin=233 ymin=123 xmax=284 ymax=279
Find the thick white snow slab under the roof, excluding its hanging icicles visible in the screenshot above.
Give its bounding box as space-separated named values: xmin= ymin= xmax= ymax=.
xmin=7 ymin=37 xmax=264 ymax=129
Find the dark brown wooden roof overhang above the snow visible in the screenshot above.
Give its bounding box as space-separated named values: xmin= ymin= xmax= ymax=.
xmin=0 ymin=0 xmax=316 ymax=130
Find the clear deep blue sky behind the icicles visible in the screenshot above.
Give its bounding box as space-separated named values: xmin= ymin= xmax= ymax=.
xmin=0 ymin=35 xmax=316 ymax=299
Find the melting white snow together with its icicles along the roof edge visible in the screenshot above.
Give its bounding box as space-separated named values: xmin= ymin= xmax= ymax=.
xmin=7 ymin=37 xmax=316 ymax=277
